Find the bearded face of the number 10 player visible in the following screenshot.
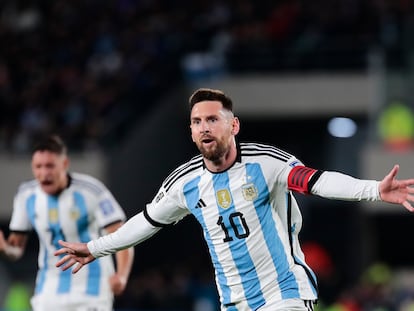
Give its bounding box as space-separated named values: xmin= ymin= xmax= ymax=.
xmin=190 ymin=101 xmax=235 ymax=162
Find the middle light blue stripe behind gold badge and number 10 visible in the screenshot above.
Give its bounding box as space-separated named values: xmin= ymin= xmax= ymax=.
xmin=213 ymin=172 xmax=265 ymax=310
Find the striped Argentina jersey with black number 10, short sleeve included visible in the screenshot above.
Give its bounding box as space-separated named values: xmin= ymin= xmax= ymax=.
xmin=146 ymin=143 xmax=317 ymax=310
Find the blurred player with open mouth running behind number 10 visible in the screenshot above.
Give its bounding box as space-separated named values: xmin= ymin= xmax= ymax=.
xmin=0 ymin=135 xmax=134 ymax=311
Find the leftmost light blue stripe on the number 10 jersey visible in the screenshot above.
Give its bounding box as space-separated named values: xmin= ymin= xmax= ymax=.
xmin=184 ymin=177 xmax=231 ymax=303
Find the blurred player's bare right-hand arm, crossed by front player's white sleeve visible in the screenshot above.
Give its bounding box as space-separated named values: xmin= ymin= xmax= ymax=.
xmin=105 ymin=222 xmax=134 ymax=295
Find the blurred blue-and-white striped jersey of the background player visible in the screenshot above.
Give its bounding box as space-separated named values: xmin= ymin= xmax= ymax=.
xmin=10 ymin=173 xmax=125 ymax=301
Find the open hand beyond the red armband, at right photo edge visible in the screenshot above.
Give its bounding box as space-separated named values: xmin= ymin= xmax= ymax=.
xmin=379 ymin=165 xmax=414 ymax=212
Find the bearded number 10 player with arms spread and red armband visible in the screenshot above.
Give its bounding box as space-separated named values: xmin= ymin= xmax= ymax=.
xmin=55 ymin=89 xmax=414 ymax=311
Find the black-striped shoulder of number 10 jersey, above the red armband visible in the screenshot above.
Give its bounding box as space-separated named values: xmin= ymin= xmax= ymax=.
xmin=240 ymin=142 xmax=294 ymax=162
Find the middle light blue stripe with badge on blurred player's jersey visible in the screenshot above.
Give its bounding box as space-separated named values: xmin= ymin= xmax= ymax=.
xmin=45 ymin=195 xmax=72 ymax=294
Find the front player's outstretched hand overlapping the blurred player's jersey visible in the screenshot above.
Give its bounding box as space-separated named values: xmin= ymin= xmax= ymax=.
xmin=55 ymin=240 xmax=95 ymax=273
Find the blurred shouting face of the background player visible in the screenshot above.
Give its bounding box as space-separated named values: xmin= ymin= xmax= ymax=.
xmin=32 ymin=151 xmax=69 ymax=195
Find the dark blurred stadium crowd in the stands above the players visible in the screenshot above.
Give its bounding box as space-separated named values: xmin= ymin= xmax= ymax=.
xmin=0 ymin=0 xmax=413 ymax=152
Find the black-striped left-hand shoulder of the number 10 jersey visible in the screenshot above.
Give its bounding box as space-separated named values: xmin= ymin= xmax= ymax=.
xmin=163 ymin=155 xmax=204 ymax=191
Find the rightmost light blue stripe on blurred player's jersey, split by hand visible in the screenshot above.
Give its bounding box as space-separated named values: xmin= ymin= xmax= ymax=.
xmin=73 ymin=192 xmax=101 ymax=296
